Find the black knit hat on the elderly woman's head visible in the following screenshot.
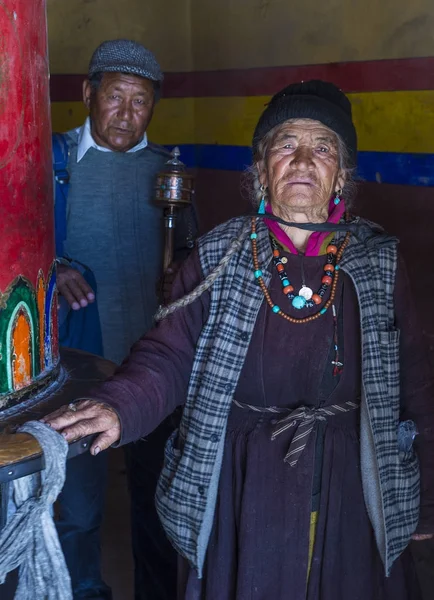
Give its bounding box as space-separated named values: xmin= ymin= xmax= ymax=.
xmin=253 ymin=80 xmax=357 ymax=166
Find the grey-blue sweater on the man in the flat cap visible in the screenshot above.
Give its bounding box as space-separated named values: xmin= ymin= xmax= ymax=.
xmin=65 ymin=130 xmax=170 ymax=363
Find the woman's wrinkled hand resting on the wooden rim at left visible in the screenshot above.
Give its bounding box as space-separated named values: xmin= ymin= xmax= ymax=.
xmin=42 ymin=400 xmax=121 ymax=456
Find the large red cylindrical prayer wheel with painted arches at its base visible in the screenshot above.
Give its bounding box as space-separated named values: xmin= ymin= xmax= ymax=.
xmin=0 ymin=0 xmax=59 ymax=410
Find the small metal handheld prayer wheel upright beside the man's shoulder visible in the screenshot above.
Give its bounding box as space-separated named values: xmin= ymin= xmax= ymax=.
xmin=155 ymin=148 xmax=194 ymax=272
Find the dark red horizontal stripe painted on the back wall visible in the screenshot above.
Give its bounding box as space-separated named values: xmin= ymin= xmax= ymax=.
xmin=51 ymin=57 xmax=434 ymax=102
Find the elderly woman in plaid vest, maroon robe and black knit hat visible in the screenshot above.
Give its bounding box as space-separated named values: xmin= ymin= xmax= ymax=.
xmin=48 ymin=81 xmax=434 ymax=600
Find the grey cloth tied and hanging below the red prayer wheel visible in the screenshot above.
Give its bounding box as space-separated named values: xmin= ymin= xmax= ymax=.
xmin=0 ymin=421 xmax=72 ymax=600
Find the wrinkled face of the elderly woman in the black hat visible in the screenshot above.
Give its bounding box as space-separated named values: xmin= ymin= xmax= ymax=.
xmin=258 ymin=119 xmax=345 ymax=213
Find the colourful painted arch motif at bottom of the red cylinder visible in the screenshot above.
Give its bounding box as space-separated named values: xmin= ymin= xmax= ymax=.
xmin=0 ymin=265 xmax=59 ymax=398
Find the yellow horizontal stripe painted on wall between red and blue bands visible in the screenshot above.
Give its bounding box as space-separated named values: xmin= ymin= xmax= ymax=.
xmin=52 ymin=90 xmax=434 ymax=154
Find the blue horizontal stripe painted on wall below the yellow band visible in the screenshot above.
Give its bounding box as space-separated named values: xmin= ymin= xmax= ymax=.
xmin=168 ymin=144 xmax=434 ymax=186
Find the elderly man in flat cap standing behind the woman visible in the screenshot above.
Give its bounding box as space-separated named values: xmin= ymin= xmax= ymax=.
xmin=56 ymin=40 xmax=193 ymax=600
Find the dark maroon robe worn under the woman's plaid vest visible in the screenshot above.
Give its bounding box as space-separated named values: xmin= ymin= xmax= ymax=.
xmin=98 ymin=244 xmax=434 ymax=600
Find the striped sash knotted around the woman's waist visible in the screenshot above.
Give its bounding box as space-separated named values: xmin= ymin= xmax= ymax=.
xmin=233 ymin=399 xmax=360 ymax=467
